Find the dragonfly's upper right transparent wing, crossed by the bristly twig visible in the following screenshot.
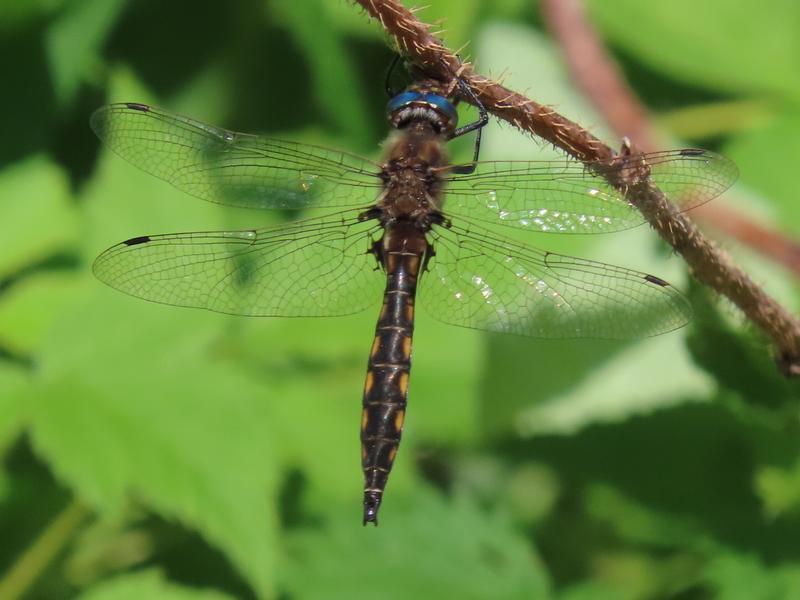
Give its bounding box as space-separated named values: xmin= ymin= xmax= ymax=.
xmin=445 ymin=149 xmax=737 ymax=233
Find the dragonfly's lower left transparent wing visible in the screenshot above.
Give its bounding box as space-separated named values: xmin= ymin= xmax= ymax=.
xmin=93 ymin=211 xmax=384 ymax=317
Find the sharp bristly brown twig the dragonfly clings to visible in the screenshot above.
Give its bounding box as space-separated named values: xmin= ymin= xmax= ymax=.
xmin=356 ymin=0 xmax=800 ymax=376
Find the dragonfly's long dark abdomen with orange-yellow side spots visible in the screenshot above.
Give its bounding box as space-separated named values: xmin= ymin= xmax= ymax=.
xmin=361 ymin=222 xmax=428 ymax=525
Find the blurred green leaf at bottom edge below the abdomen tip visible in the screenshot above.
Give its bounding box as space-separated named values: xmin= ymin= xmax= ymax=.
xmin=285 ymin=487 xmax=549 ymax=600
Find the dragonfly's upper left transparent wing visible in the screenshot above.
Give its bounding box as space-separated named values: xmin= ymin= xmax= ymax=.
xmin=90 ymin=103 xmax=381 ymax=208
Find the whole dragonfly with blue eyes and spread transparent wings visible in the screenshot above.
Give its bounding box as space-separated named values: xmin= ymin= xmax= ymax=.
xmin=91 ymin=76 xmax=736 ymax=525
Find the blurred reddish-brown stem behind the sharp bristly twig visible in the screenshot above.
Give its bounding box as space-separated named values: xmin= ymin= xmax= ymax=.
xmin=541 ymin=0 xmax=800 ymax=275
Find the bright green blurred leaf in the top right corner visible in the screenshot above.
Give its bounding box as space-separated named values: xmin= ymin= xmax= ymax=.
xmin=589 ymin=0 xmax=800 ymax=97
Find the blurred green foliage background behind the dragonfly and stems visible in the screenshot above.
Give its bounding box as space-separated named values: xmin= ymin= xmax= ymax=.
xmin=0 ymin=0 xmax=800 ymax=600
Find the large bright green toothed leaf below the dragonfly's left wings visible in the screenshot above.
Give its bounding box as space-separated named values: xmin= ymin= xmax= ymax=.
xmin=31 ymin=284 xmax=280 ymax=595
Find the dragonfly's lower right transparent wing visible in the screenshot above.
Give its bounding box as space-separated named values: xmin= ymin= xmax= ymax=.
xmin=419 ymin=224 xmax=692 ymax=339
